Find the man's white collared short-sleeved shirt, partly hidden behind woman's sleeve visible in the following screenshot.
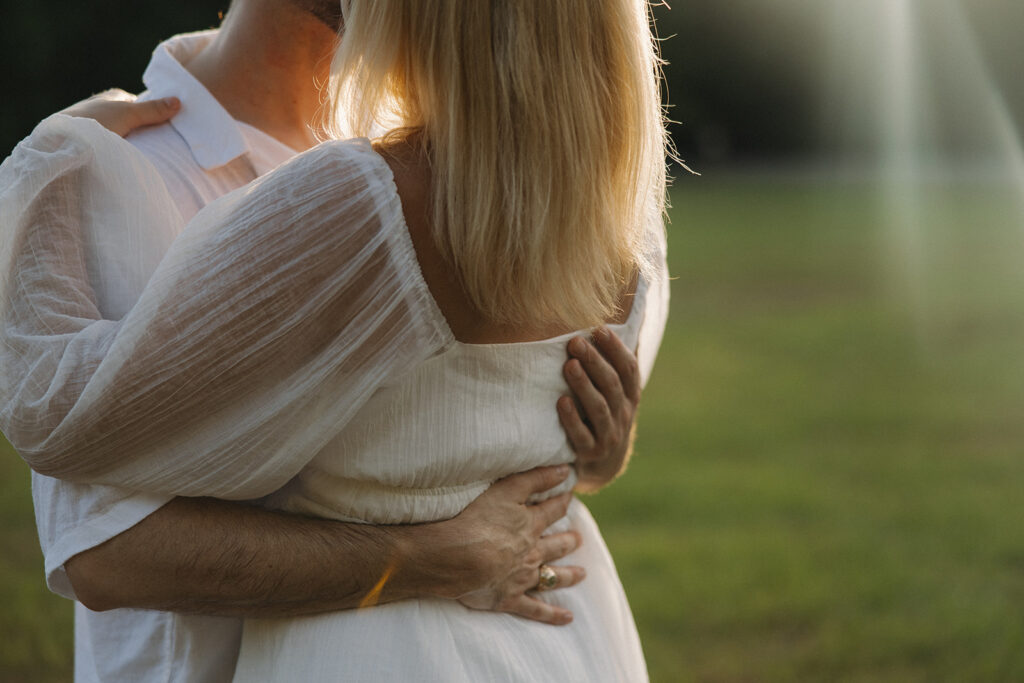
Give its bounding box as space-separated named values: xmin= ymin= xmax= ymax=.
xmin=33 ymin=31 xmax=295 ymax=683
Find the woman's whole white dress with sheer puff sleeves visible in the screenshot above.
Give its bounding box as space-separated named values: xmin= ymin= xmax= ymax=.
xmin=0 ymin=116 xmax=668 ymax=682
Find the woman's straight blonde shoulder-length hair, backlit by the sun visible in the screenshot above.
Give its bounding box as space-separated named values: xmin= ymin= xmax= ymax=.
xmin=330 ymin=0 xmax=667 ymax=329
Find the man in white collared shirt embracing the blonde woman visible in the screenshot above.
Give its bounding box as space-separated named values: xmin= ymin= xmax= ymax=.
xmin=33 ymin=0 xmax=647 ymax=682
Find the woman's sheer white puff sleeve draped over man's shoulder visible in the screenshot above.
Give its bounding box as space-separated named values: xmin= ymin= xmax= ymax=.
xmin=0 ymin=116 xmax=452 ymax=499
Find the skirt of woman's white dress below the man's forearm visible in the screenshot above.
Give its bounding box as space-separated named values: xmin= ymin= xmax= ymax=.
xmin=233 ymin=500 xmax=647 ymax=683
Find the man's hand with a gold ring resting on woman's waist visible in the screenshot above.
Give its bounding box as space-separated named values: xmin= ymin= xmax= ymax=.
xmin=414 ymin=465 xmax=586 ymax=625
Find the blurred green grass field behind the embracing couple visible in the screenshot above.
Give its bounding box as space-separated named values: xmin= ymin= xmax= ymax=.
xmin=0 ymin=178 xmax=1024 ymax=682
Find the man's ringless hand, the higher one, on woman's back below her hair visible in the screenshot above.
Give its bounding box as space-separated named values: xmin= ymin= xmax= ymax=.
xmin=558 ymin=328 xmax=640 ymax=493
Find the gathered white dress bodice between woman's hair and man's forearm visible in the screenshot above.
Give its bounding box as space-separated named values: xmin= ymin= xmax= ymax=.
xmin=267 ymin=255 xmax=647 ymax=524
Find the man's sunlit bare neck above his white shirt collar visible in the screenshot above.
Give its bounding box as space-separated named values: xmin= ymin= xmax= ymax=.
xmin=184 ymin=0 xmax=337 ymax=152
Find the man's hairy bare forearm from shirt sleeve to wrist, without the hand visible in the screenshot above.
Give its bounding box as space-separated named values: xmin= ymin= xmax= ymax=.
xmin=66 ymin=498 xmax=444 ymax=616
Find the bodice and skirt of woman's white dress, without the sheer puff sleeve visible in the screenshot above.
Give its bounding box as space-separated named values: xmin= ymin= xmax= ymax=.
xmin=234 ymin=254 xmax=665 ymax=683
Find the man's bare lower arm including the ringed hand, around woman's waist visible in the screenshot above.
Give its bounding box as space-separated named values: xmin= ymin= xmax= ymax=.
xmin=65 ymin=466 xmax=584 ymax=624
